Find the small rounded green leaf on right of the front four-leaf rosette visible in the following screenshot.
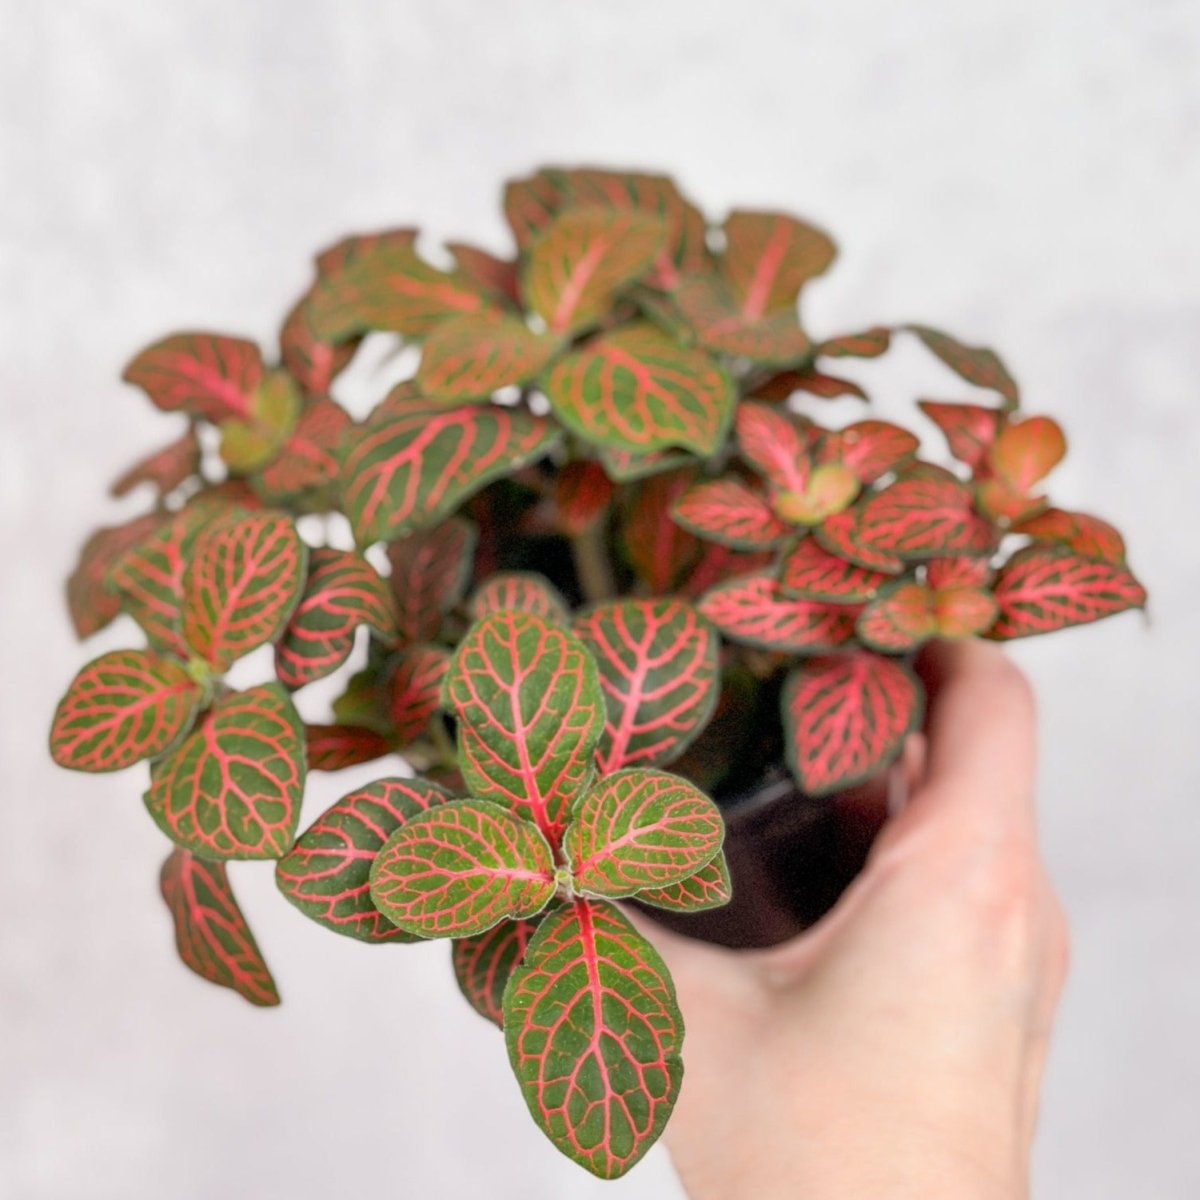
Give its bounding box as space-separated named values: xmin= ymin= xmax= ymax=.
xmin=563 ymin=770 xmax=725 ymax=899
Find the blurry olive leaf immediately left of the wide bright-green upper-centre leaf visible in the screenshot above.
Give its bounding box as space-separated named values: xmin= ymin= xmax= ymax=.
xmin=416 ymin=314 xmax=560 ymax=401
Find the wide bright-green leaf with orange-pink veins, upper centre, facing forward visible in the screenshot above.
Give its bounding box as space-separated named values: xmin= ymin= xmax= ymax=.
xmin=542 ymin=323 xmax=734 ymax=455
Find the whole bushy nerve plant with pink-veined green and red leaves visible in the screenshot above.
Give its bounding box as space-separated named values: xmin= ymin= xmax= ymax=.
xmin=50 ymin=169 xmax=1145 ymax=1177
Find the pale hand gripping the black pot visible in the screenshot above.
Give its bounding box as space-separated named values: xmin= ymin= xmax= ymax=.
xmin=638 ymin=643 xmax=1067 ymax=1200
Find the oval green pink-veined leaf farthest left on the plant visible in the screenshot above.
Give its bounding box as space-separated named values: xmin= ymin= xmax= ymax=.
xmin=50 ymin=650 xmax=202 ymax=772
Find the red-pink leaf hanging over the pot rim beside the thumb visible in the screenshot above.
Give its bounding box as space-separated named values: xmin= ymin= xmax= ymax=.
xmin=782 ymin=650 xmax=924 ymax=796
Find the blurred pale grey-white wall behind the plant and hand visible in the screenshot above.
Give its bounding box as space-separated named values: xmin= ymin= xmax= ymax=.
xmin=0 ymin=0 xmax=1200 ymax=1200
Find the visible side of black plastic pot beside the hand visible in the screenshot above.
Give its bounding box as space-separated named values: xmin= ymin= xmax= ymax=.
xmin=646 ymin=769 xmax=902 ymax=949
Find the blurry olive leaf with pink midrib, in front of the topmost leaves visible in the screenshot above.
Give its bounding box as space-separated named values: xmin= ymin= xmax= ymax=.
xmin=521 ymin=208 xmax=666 ymax=335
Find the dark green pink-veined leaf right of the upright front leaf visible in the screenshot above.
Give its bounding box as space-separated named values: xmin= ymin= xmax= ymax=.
xmin=575 ymin=599 xmax=720 ymax=774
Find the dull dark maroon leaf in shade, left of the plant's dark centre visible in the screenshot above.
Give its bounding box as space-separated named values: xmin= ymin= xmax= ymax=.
xmin=388 ymin=517 xmax=475 ymax=642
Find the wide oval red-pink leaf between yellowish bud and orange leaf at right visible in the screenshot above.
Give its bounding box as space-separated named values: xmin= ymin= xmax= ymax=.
xmin=857 ymin=479 xmax=995 ymax=558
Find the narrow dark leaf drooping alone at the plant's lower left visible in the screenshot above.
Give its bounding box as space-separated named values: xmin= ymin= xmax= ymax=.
xmin=160 ymin=850 xmax=280 ymax=1007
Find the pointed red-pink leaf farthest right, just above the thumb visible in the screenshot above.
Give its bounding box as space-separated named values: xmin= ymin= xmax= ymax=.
xmin=990 ymin=545 xmax=1146 ymax=641
